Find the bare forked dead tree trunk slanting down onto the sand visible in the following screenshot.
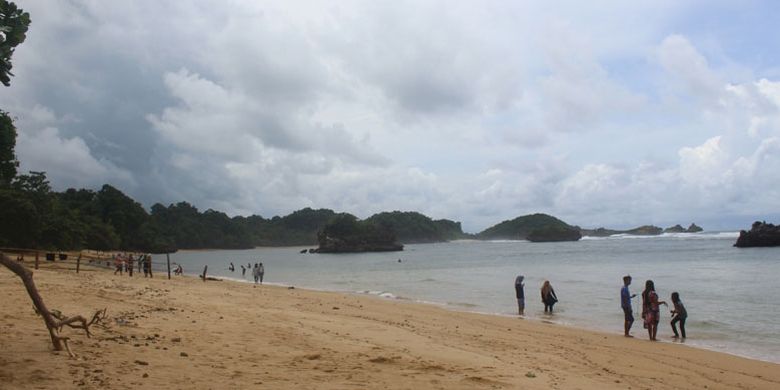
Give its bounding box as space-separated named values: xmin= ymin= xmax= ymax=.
xmin=0 ymin=253 xmax=106 ymax=356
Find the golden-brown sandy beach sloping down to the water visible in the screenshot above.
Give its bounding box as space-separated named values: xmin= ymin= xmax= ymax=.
xmin=0 ymin=262 xmax=780 ymax=389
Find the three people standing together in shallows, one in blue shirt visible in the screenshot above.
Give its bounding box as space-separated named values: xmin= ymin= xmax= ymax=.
xmin=620 ymin=275 xmax=688 ymax=341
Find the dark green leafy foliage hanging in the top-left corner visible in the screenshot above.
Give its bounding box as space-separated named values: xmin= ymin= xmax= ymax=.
xmin=0 ymin=0 xmax=30 ymax=87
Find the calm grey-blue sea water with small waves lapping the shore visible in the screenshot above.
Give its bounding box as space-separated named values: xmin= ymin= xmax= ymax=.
xmin=165 ymin=232 xmax=780 ymax=363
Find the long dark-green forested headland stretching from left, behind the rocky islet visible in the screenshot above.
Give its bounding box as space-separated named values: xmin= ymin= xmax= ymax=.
xmin=0 ymin=172 xmax=464 ymax=252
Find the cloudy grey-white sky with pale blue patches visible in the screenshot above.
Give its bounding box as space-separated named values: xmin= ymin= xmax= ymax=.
xmin=0 ymin=0 xmax=780 ymax=232
